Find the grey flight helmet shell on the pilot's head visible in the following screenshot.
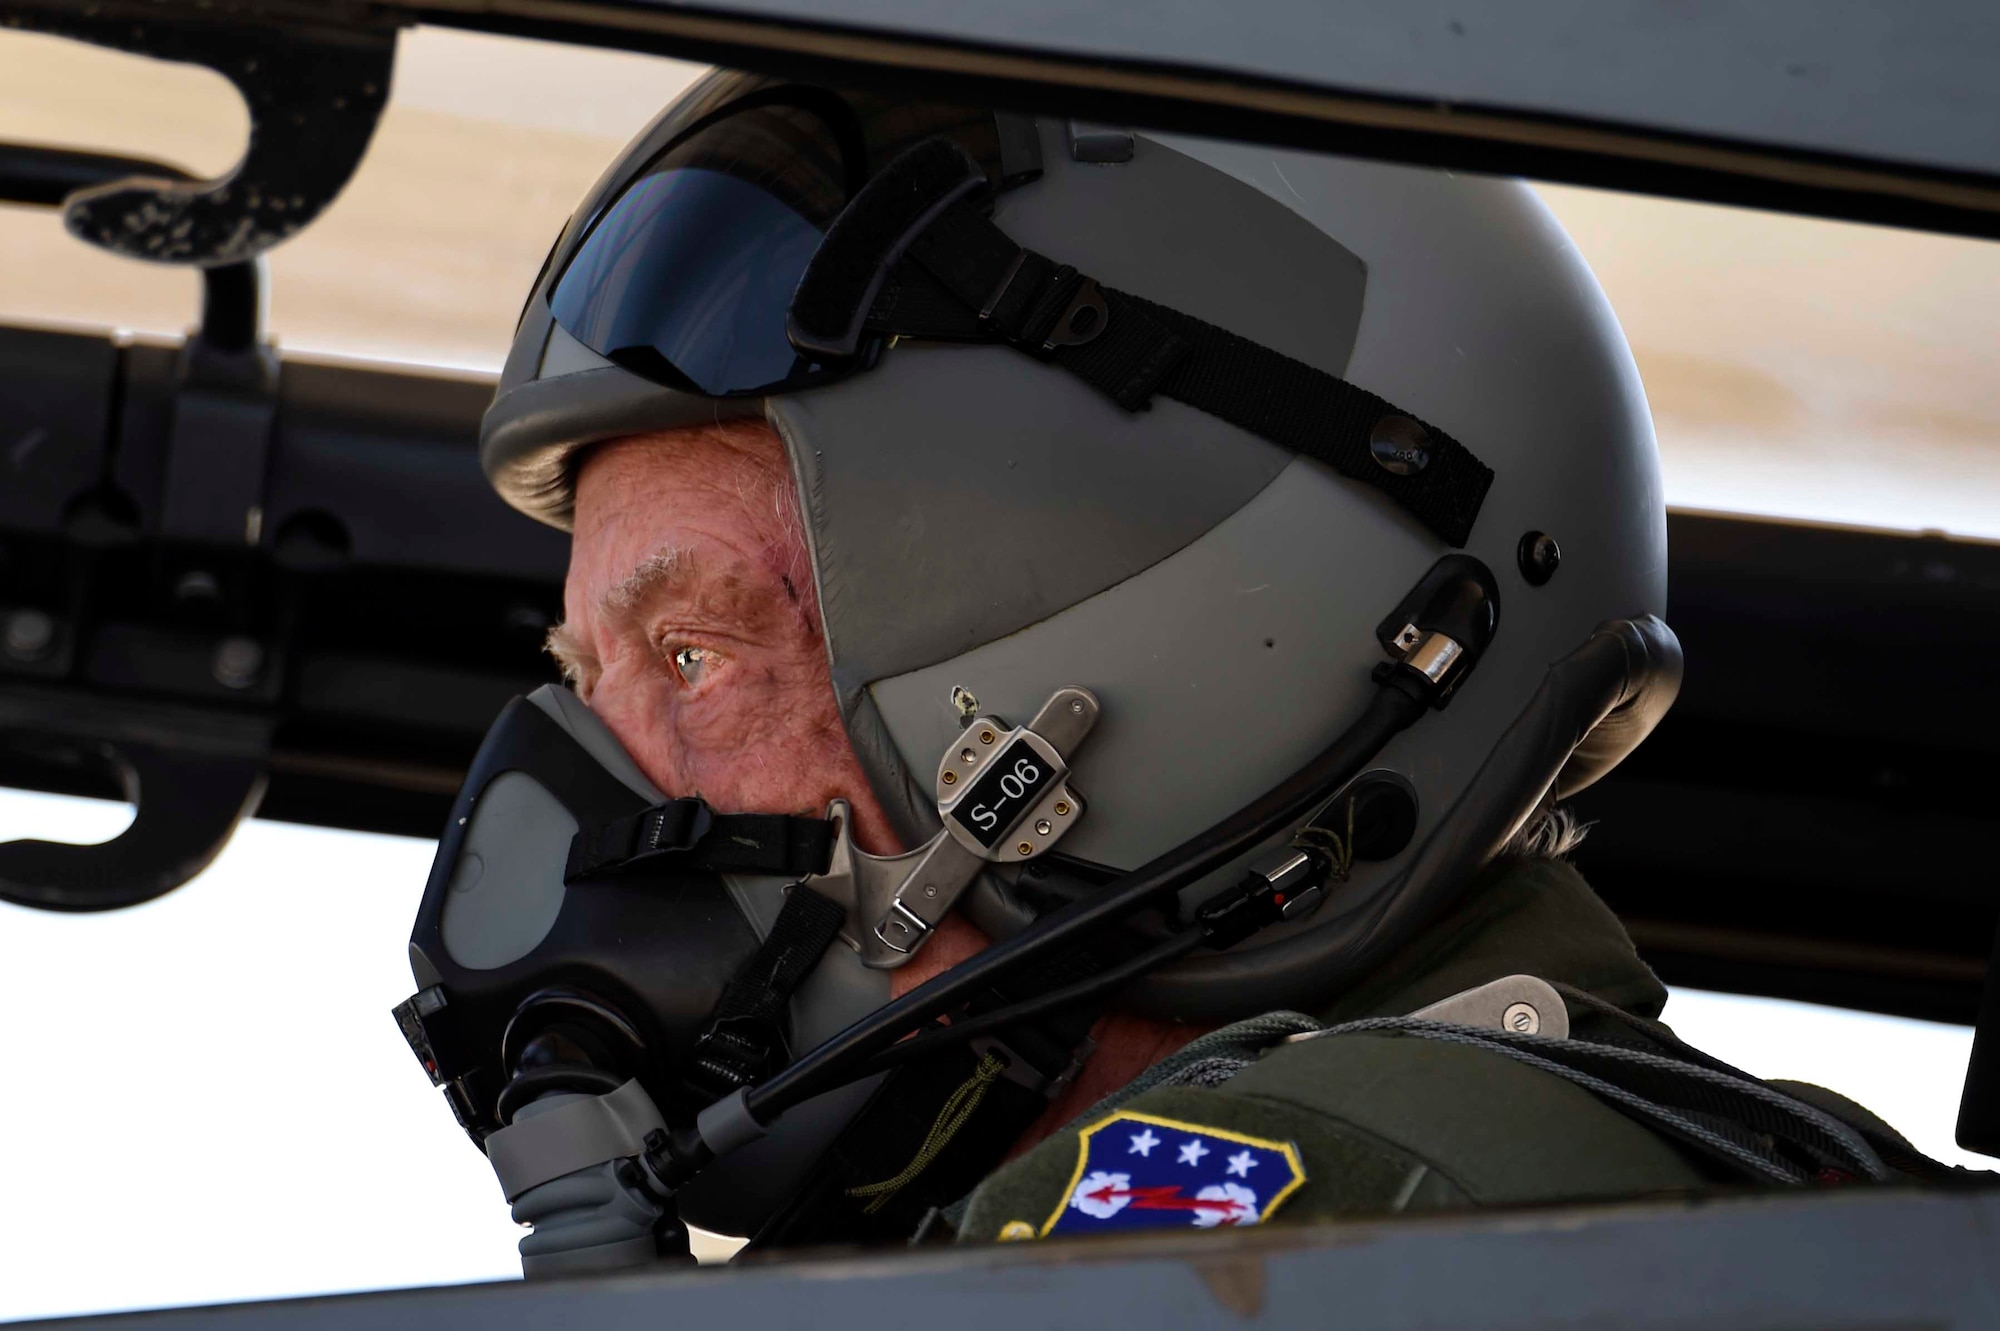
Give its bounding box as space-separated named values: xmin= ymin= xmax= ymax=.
xmin=482 ymin=90 xmax=1680 ymax=1021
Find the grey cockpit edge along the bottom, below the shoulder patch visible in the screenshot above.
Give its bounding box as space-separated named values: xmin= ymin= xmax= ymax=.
xmin=22 ymin=1187 xmax=2000 ymax=1331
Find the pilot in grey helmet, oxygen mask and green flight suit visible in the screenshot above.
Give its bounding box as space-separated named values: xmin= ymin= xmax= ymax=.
xmin=398 ymin=74 xmax=1952 ymax=1275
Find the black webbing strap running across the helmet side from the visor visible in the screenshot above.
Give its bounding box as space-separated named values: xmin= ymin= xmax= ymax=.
xmin=868 ymin=192 xmax=1494 ymax=546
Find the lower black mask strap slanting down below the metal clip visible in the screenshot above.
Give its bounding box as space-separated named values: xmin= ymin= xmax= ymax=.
xmin=682 ymin=883 xmax=848 ymax=1097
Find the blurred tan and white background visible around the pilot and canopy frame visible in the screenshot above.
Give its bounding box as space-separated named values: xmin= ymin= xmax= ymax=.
xmin=0 ymin=18 xmax=2000 ymax=1319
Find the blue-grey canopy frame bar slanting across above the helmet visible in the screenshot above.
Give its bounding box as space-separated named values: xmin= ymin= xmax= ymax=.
xmin=388 ymin=0 xmax=2000 ymax=236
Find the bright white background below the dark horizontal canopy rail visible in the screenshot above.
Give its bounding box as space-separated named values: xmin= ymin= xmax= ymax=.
xmin=0 ymin=789 xmax=1992 ymax=1319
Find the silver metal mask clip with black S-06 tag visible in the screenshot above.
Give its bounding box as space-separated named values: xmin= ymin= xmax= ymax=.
xmin=806 ymin=687 xmax=1098 ymax=969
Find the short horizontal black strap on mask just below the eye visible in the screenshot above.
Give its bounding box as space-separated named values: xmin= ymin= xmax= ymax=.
xmin=562 ymin=799 xmax=834 ymax=883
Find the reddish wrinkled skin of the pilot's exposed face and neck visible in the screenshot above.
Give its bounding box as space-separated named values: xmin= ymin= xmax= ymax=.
xmin=550 ymin=422 xmax=1198 ymax=1147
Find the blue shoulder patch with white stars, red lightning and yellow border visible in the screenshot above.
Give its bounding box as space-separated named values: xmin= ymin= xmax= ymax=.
xmin=1040 ymin=1109 xmax=1306 ymax=1235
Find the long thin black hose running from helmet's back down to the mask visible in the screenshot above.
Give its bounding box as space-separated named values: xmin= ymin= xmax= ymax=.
xmin=744 ymin=671 xmax=1430 ymax=1123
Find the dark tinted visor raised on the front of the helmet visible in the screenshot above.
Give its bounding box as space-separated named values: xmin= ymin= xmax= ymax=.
xmin=548 ymin=84 xmax=1038 ymax=398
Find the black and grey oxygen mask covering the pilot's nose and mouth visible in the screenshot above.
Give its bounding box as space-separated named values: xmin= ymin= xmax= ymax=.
xmin=396 ymin=687 xmax=888 ymax=1233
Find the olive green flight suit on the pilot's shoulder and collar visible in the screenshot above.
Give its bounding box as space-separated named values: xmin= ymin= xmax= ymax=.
xmin=958 ymin=861 xmax=1718 ymax=1241
